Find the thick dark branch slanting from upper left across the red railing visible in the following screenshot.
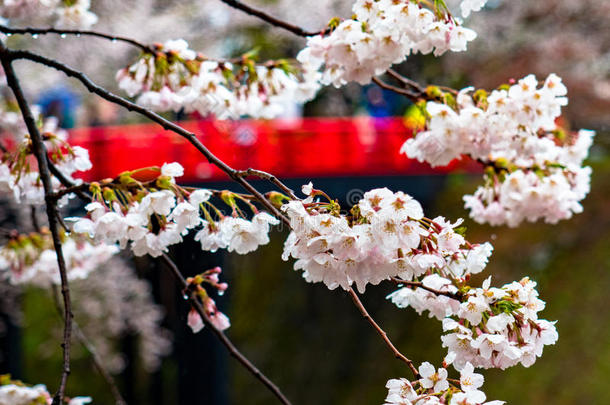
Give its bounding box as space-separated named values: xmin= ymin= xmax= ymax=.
xmin=7 ymin=50 xmax=288 ymax=223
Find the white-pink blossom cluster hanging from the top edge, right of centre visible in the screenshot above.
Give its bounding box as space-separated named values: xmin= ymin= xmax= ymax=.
xmin=297 ymin=0 xmax=486 ymax=87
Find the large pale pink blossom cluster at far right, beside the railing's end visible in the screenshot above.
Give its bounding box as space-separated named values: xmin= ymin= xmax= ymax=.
xmin=401 ymin=74 xmax=595 ymax=226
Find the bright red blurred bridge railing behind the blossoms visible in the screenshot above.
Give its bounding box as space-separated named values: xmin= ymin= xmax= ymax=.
xmin=70 ymin=117 xmax=479 ymax=182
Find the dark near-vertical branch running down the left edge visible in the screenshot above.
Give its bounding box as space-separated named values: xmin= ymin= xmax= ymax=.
xmin=0 ymin=42 xmax=72 ymax=405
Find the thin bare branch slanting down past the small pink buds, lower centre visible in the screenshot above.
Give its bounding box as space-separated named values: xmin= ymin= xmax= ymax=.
xmin=161 ymin=253 xmax=290 ymax=405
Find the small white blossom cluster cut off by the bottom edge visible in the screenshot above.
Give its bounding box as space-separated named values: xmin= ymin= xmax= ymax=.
xmin=384 ymin=362 xmax=505 ymax=405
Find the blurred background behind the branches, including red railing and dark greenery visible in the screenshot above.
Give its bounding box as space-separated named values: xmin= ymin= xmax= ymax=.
xmin=0 ymin=0 xmax=610 ymax=405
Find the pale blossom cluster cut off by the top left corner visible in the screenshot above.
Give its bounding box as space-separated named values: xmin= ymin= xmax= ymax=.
xmin=0 ymin=0 xmax=98 ymax=29
